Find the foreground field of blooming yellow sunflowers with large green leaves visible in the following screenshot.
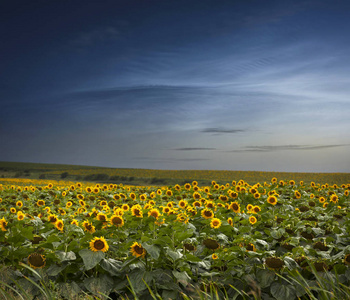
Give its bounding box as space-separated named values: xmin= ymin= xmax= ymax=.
xmin=0 ymin=178 xmax=350 ymax=300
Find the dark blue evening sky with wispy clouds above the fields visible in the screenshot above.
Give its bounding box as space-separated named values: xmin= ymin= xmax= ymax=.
xmin=0 ymin=0 xmax=350 ymax=172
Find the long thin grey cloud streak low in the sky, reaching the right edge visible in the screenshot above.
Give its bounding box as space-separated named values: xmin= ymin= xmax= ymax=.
xmin=230 ymin=144 xmax=349 ymax=152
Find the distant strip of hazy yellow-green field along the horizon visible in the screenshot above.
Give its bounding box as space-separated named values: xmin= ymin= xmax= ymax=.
xmin=0 ymin=162 xmax=350 ymax=185
